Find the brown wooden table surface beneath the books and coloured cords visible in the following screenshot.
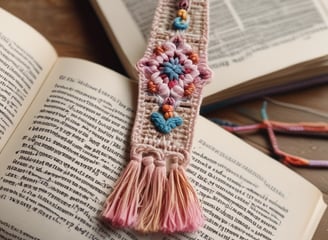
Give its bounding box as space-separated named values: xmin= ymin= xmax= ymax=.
xmin=0 ymin=0 xmax=328 ymax=240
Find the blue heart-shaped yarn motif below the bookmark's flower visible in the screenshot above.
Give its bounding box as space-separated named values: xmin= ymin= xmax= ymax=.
xmin=150 ymin=112 xmax=183 ymax=134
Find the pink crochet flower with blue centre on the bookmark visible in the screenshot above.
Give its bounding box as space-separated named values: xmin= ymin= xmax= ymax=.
xmin=138 ymin=38 xmax=211 ymax=105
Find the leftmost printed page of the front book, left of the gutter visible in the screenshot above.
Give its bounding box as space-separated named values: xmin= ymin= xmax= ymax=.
xmin=0 ymin=8 xmax=57 ymax=152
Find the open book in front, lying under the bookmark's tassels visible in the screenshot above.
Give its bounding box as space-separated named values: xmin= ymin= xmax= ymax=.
xmin=0 ymin=9 xmax=326 ymax=240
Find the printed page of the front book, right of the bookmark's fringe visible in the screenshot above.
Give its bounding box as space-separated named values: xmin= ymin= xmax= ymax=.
xmin=189 ymin=121 xmax=325 ymax=240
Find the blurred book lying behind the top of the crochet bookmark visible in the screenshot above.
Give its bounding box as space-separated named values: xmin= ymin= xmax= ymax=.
xmin=91 ymin=0 xmax=328 ymax=106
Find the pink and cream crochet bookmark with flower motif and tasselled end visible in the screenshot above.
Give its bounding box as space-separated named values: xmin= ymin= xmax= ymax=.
xmin=102 ymin=0 xmax=211 ymax=233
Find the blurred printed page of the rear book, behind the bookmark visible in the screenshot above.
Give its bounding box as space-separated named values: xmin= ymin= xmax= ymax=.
xmin=91 ymin=0 xmax=328 ymax=98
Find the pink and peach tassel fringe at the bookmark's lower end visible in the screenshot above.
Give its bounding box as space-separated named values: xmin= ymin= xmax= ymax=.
xmin=102 ymin=145 xmax=204 ymax=233
